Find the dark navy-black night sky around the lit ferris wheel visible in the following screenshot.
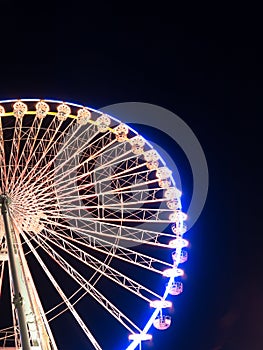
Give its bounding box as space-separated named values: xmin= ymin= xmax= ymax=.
xmin=0 ymin=1 xmax=263 ymax=350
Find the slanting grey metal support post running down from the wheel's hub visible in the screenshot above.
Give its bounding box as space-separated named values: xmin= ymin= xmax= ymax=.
xmin=0 ymin=195 xmax=31 ymax=350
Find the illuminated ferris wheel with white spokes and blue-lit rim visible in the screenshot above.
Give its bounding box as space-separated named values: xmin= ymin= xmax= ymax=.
xmin=0 ymin=99 xmax=188 ymax=350
